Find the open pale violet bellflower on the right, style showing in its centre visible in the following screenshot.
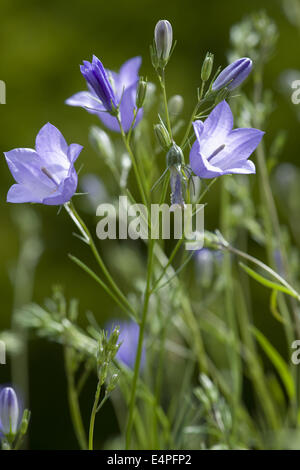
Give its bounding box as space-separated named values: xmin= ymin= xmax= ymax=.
xmin=190 ymin=101 xmax=264 ymax=178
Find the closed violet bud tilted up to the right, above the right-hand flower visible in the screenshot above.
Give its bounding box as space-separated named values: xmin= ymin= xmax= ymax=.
xmin=212 ymin=57 xmax=252 ymax=91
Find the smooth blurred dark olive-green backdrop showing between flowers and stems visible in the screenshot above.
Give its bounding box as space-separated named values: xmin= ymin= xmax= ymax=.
xmin=0 ymin=0 xmax=300 ymax=449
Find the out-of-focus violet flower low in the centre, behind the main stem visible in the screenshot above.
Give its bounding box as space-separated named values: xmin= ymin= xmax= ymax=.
xmin=107 ymin=320 xmax=146 ymax=369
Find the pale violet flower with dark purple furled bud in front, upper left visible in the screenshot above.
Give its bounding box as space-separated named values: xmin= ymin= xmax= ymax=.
xmin=66 ymin=56 xmax=143 ymax=132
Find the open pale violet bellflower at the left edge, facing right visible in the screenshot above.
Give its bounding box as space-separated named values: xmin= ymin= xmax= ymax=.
xmin=4 ymin=122 xmax=82 ymax=205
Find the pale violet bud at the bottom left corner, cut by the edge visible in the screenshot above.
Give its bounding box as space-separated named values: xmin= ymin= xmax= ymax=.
xmin=0 ymin=387 xmax=19 ymax=435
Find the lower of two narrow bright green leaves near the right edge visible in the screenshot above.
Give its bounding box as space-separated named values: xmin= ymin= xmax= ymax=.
xmin=251 ymin=326 xmax=295 ymax=400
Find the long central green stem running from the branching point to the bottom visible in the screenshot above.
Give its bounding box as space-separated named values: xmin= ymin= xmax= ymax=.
xmin=126 ymin=239 xmax=154 ymax=449
